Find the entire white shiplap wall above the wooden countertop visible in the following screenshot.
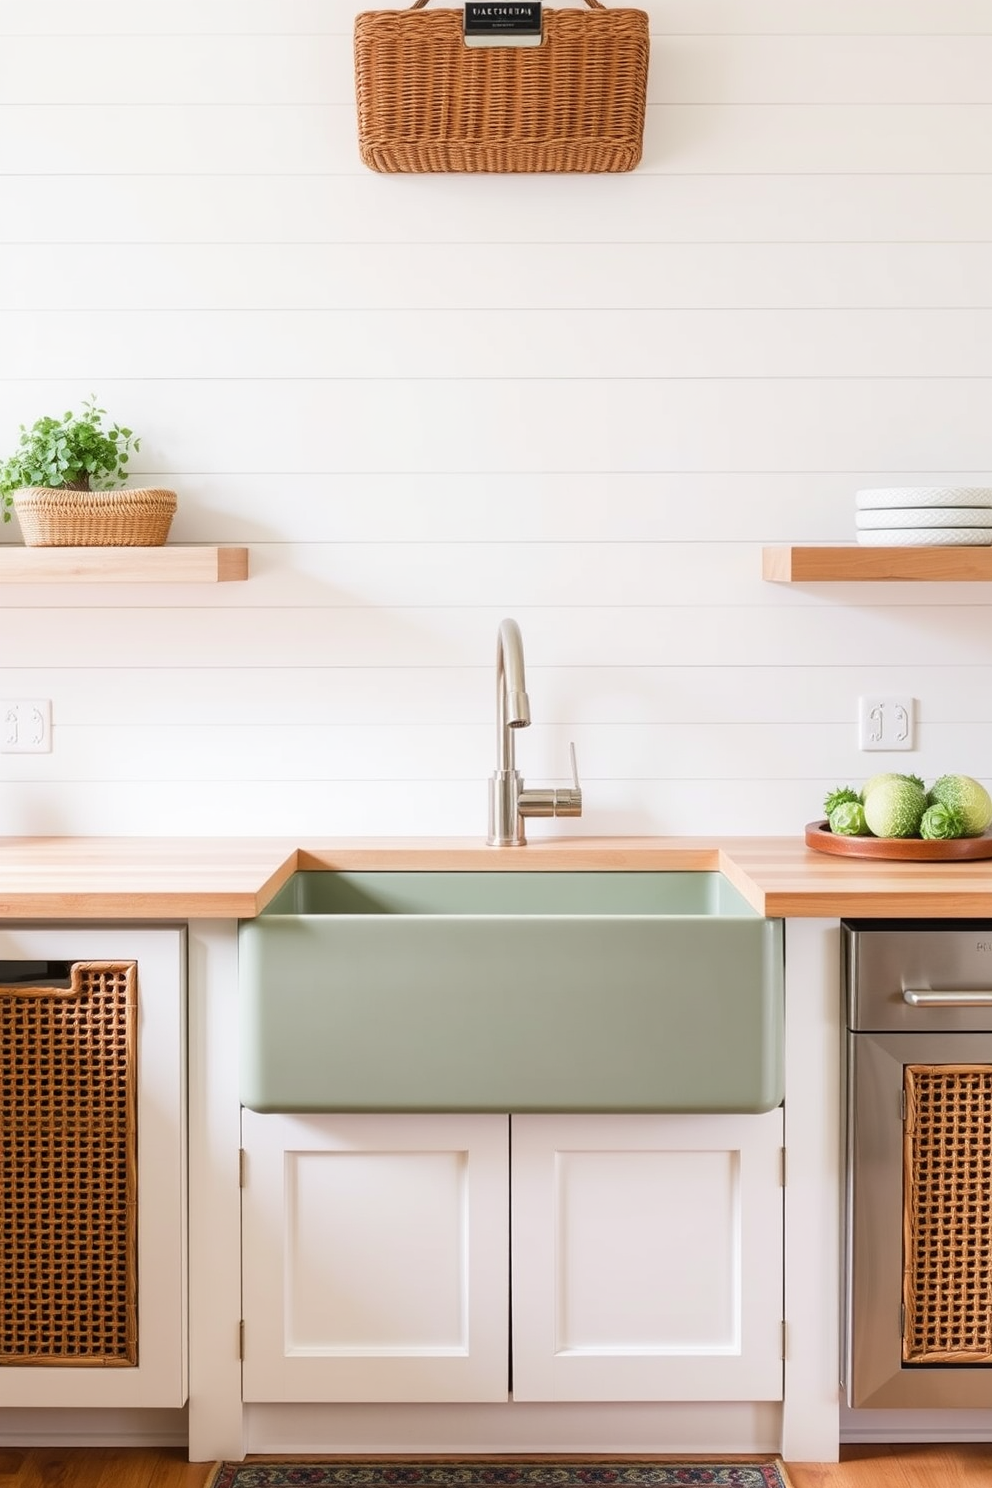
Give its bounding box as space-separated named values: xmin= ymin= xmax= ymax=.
xmin=0 ymin=0 xmax=992 ymax=836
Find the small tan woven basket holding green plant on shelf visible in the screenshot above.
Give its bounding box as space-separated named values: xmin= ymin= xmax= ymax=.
xmin=13 ymin=485 xmax=177 ymax=548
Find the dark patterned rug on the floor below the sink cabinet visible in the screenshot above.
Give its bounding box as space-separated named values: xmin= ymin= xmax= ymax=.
xmin=208 ymin=1457 xmax=790 ymax=1488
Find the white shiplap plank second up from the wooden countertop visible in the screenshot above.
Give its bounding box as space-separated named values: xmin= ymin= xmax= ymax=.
xmin=4 ymin=722 xmax=988 ymax=785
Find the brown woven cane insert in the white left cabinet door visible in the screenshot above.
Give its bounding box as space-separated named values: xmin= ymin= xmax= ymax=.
xmin=0 ymin=961 xmax=138 ymax=1366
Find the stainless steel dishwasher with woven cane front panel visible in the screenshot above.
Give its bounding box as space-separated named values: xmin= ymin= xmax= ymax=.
xmin=842 ymin=920 xmax=992 ymax=1409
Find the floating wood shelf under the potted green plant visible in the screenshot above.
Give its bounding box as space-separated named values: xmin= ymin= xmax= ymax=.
xmin=0 ymin=543 xmax=248 ymax=583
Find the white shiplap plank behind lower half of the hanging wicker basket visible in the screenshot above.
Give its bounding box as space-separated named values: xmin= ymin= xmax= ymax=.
xmin=0 ymin=104 xmax=992 ymax=175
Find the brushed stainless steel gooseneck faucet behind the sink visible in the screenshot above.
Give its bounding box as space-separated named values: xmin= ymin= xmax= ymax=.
xmin=486 ymin=620 xmax=582 ymax=847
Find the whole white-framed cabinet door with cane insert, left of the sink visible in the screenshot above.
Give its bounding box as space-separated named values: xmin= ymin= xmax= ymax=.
xmin=0 ymin=924 xmax=186 ymax=1406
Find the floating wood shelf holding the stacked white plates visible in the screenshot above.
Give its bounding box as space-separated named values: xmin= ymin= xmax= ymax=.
xmin=761 ymin=546 xmax=992 ymax=583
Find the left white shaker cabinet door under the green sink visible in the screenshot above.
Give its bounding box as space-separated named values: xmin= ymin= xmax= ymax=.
xmin=242 ymin=1110 xmax=509 ymax=1402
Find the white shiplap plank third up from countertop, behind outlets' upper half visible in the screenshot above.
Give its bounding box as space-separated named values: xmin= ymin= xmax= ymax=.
xmin=7 ymin=666 xmax=992 ymax=729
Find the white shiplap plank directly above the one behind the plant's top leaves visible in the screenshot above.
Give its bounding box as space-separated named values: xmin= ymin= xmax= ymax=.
xmin=0 ymin=305 xmax=992 ymax=382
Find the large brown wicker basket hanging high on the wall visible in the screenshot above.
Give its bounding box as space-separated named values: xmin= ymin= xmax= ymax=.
xmin=354 ymin=0 xmax=650 ymax=173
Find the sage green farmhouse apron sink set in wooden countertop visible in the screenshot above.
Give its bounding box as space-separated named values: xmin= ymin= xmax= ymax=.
xmin=238 ymin=870 xmax=784 ymax=1112
